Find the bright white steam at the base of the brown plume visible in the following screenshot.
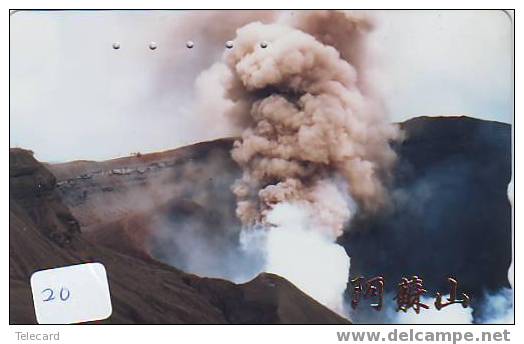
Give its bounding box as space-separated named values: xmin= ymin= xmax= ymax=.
xmin=242 ymin=198 xmax=350 ymax=314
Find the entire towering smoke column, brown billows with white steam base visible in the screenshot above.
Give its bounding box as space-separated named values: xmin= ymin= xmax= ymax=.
xmin=190 ymin=11 xmax=399 ymax=312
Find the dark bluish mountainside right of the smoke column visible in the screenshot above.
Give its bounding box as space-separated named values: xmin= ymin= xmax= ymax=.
xmin=340 ymin=117 xmax=512 ymax=301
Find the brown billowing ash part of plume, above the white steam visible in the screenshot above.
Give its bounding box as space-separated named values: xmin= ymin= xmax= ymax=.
xmin=225 ymin=16 xmax=398 ymax=227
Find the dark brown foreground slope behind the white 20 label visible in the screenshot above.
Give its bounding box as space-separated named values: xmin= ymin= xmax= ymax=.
xmin=9 ymin=149 xmax=349 ymax=324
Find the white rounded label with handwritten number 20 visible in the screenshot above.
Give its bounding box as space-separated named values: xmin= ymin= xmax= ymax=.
xmin=31 ymin=263 xmax=112 ymax=324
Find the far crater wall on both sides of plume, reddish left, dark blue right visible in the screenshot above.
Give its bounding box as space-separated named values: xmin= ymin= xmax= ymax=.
xmin=46 ymin=117 xmax=512 ymax=306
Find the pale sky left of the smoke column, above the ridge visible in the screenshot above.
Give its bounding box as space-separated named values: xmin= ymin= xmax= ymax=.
xmin=10 ymin=10 xmax=277 ymax=162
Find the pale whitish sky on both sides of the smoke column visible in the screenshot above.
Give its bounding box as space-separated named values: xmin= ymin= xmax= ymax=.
xmin=10 ymin=11 xmax=513 ymax=162
